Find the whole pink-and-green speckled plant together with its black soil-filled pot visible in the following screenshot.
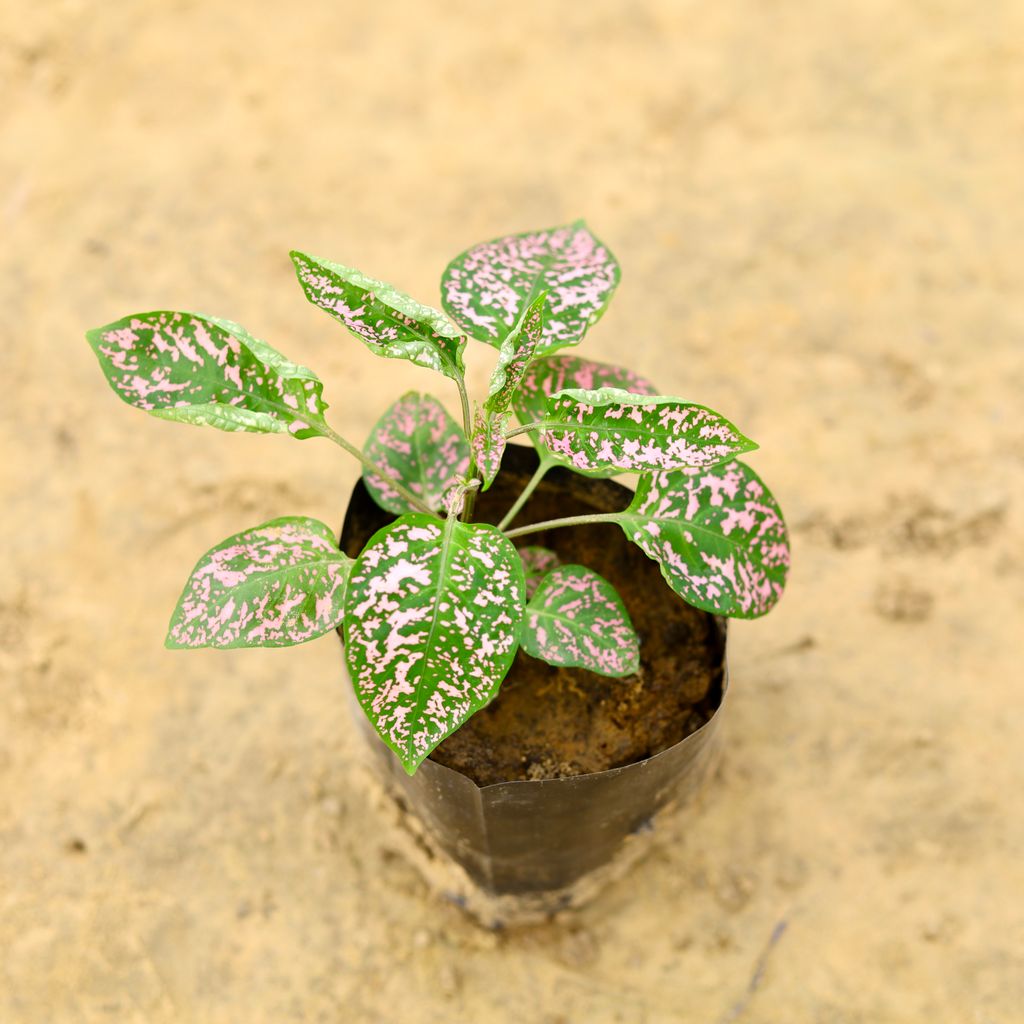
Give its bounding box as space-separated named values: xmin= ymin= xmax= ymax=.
xmin=87 ymin=222 xmax=790 ymax=929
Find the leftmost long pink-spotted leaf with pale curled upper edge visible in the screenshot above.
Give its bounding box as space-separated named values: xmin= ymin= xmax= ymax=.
xmin=86 ymin=310 xmax=327 ymax=437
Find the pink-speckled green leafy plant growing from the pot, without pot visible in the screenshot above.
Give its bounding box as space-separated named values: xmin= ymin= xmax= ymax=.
xmin=87 ymin=222 xmax=790 ymax=773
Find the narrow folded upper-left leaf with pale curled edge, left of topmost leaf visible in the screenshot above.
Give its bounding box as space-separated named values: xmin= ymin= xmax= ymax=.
xmin=291 ymin=252 xmax=466 ymax=380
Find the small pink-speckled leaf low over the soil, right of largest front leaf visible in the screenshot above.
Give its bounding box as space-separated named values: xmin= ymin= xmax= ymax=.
xmin=521 ymin=565 xmax=640 ymax=676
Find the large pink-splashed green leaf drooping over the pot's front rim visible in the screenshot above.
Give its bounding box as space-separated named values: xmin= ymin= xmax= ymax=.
xmin=345 ymin=513 xmax=523 ymax=774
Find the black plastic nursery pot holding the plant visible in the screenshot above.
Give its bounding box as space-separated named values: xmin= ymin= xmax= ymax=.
xmin=340 ymin=445 xmax=727 ymax=924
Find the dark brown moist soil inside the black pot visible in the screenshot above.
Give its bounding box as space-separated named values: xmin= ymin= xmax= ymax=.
xmin=345 ymin=445 xmax=722 ymax=785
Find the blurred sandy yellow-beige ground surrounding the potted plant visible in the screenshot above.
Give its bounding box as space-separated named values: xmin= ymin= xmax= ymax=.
xmin=0 ymin=0 xmax=1024 ymax=1024
